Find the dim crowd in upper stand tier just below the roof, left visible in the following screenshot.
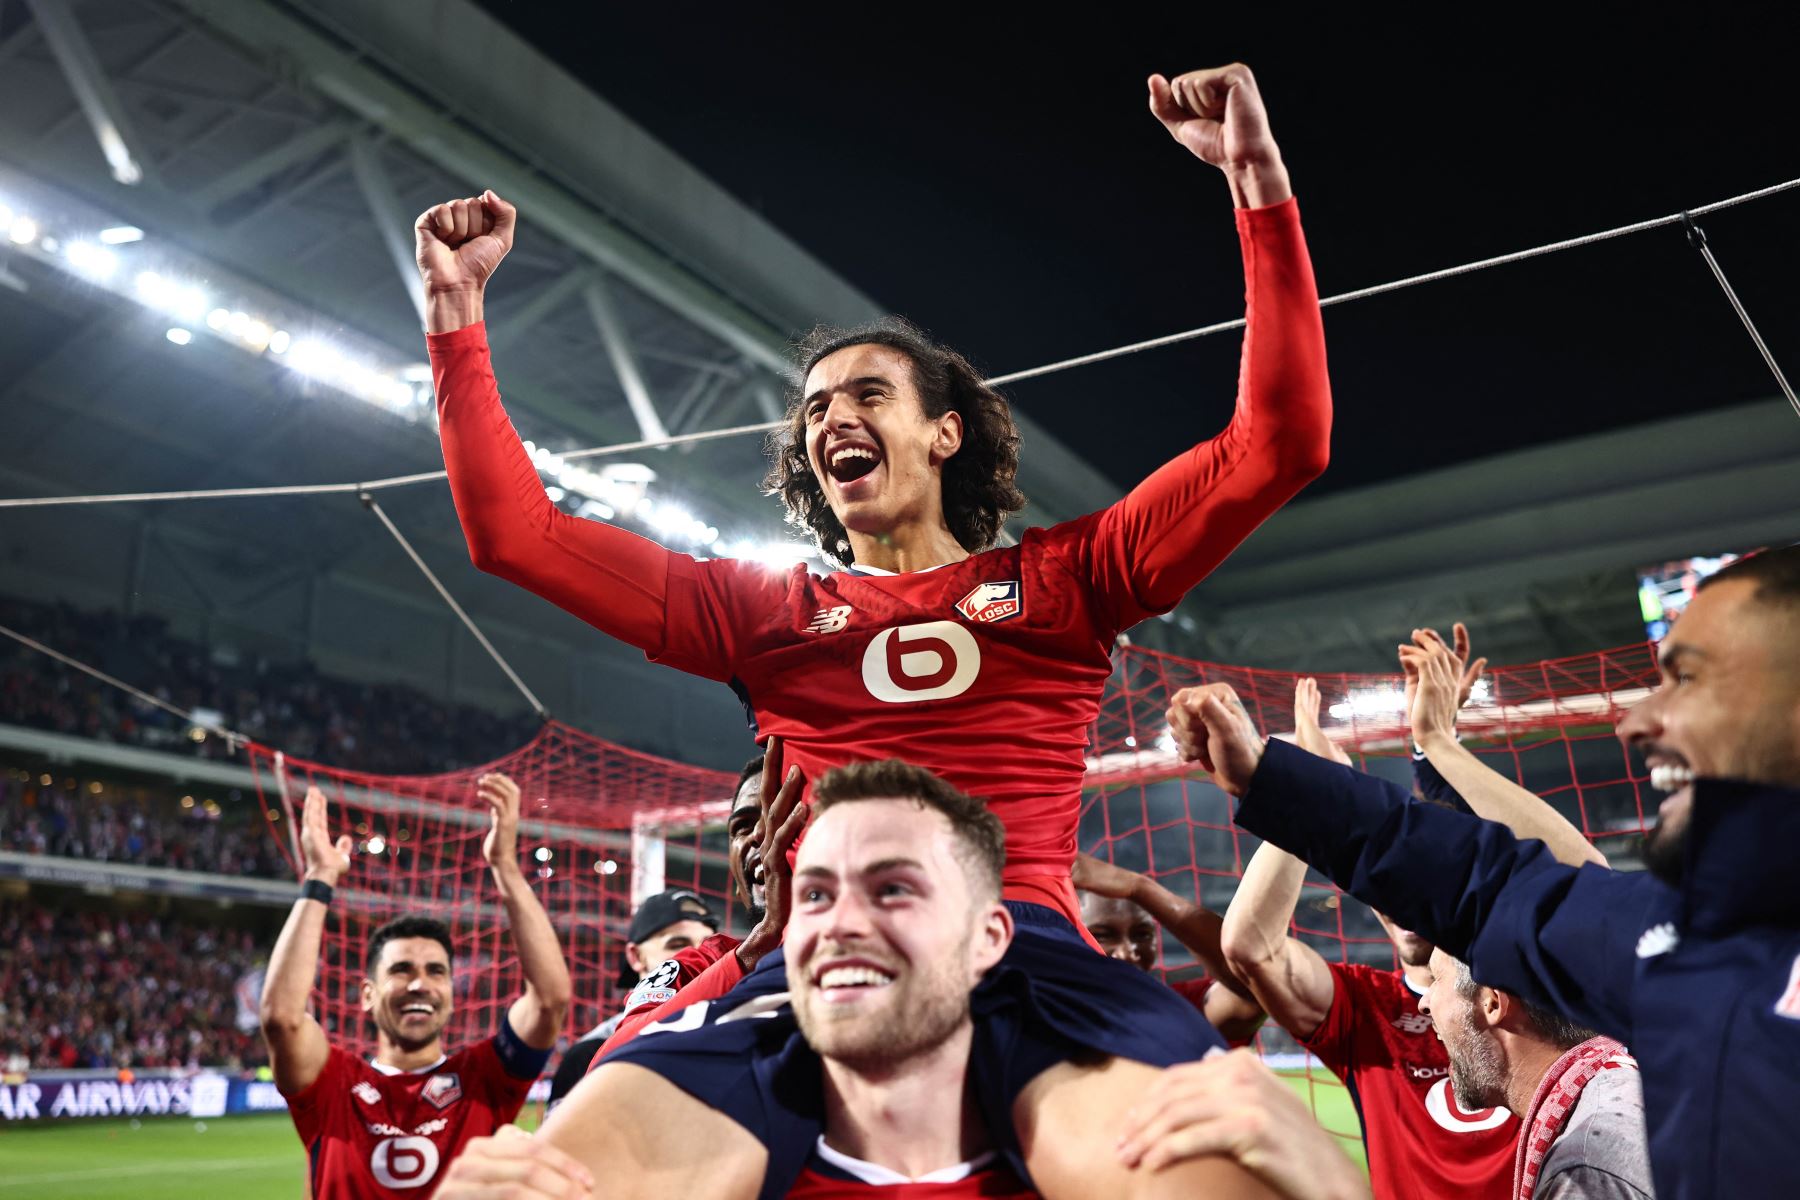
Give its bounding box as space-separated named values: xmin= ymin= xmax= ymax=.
xmin=0 ymin=597 xmax=536 ymax=774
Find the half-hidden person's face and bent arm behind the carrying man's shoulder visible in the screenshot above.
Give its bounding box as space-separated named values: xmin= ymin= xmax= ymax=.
xmin=1075 ymin=855 xmax=1264 ymax=1045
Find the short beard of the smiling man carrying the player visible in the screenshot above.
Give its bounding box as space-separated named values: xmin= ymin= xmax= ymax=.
xmin=794 ymin=963 xmax=968 ymax=1074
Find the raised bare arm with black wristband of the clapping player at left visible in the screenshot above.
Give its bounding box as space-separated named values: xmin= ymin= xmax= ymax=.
xmin=257 ymin=788 xmax=351 ymax=1096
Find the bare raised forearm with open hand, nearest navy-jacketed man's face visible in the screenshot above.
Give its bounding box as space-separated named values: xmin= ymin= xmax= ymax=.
xmin=1400 ymin=624 xmax=1607 ymax=867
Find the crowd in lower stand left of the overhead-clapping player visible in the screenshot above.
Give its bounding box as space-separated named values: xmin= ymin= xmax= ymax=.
xmin=0 ymin=900 xmax=268 ymax=1070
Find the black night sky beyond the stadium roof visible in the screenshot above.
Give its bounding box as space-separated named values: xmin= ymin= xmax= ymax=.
xmin=468 ymin=0 xmax=1800 ymax=495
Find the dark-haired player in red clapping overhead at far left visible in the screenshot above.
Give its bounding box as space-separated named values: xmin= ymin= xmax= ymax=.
xmin=261 ymin=775 xmax=569 ymax=1200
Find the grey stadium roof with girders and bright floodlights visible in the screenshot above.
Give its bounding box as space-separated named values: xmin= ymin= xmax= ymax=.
xmin=0 ymin=0 xmax=1800 ymax=765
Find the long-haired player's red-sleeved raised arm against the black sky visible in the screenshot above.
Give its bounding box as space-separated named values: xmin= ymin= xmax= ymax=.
xmin=1072 ymin=65 xmax=1332 ymax=626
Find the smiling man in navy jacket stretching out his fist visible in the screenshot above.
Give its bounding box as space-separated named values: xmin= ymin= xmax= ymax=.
xmin=1170 ymin=547 xmax=1800 ymax=1200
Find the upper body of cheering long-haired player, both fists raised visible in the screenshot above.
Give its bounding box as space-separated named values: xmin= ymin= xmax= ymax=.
xmin=418 ymin=65 xmax=1330 ymax=923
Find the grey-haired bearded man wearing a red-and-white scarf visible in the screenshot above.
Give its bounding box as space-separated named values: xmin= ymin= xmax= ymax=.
xmin=1418 ymin=950 xmax=1654 ymax=1200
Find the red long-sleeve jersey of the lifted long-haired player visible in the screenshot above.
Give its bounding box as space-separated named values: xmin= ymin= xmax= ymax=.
xmin=430 ymin=200 xmax=1330 ymax=927
